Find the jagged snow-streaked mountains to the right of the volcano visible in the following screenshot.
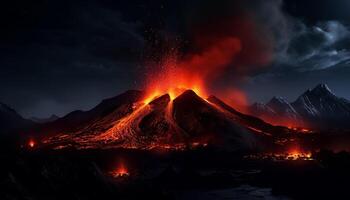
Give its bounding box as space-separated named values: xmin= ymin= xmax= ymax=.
xmin=249 ymin=84 xmax=350 ymax=129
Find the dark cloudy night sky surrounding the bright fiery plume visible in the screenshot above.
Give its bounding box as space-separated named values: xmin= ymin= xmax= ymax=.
xmin=0 ymin=0 xmax=350 ymax=117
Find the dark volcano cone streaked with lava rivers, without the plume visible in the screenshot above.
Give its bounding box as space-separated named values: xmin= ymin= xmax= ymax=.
xmin=41 ymin=90 xmax=286 ymax=151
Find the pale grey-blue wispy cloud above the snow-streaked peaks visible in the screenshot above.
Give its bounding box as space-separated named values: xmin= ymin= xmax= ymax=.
xmin=277 ymin=21 xmax=350 ymax=71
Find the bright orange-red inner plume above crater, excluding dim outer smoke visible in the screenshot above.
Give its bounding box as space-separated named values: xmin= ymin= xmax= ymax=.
xmin=144 ymin=37 xmax=241 ymax=104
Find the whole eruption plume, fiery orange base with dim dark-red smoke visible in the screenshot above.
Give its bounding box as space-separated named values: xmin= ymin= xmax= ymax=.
xmin=139 ymin=13 xmax=273 ymax=112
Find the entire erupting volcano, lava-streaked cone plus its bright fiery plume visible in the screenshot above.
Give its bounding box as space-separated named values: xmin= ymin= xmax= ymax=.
xmin=32 ymin=26 xmax=292 ymax=151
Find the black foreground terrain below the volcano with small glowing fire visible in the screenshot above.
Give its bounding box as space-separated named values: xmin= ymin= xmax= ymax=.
xmin=0 ymin=148 xmax=350 ymax=199
